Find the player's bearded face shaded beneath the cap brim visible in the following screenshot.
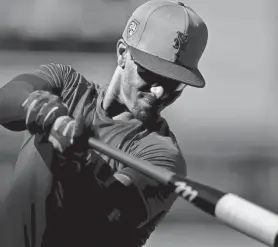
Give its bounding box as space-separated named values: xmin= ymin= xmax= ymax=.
xmin=121 ymin=53 xmax=185 ymax=121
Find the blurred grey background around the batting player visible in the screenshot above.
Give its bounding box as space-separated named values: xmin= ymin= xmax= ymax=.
xmin=0 ymin=0 xmax=278 ymax=247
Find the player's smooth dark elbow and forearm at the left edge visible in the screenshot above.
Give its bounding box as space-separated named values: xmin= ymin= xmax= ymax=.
xmin=0 ymin=74 xmax=51 ymax=131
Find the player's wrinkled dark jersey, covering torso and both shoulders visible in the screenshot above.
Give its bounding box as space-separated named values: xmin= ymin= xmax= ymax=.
xmin=0 ymin=64 xmax=185 ymax=247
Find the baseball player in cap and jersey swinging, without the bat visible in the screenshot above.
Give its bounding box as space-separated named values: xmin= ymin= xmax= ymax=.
xmin=0 ymin=0 xmax=207 ymax=247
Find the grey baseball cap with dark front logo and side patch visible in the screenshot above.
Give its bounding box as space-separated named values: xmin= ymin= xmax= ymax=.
xmin=122 ymin=0 xmax=208 ymax=88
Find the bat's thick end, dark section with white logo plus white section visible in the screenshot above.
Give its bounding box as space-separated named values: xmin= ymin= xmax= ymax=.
xmin=172 ymin=175 xmax=278 ymax=247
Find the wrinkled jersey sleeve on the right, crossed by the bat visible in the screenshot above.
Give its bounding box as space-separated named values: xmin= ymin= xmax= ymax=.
xmin=114 ymin=134 xmax=186 ymax=225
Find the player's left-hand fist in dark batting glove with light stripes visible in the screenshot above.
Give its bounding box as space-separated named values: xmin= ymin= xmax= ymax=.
xmin=22 ymin=90 xmax=68 ymax=134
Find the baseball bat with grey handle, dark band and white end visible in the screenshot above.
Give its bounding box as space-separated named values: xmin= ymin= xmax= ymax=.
xmin=89 ymin=138 xmax=278 ymax=247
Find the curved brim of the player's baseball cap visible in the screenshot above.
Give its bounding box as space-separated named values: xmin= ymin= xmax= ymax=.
xmin=129 ymin=46 xmax=205 ymax=88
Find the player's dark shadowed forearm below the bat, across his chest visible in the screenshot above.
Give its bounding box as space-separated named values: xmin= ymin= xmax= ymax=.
xmin=55 ymin=164 xmax=148 ymax=228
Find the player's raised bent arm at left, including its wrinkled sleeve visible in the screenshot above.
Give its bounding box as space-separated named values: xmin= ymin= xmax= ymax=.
xmin=0 ymin=64 xmax=88 ymax=131
